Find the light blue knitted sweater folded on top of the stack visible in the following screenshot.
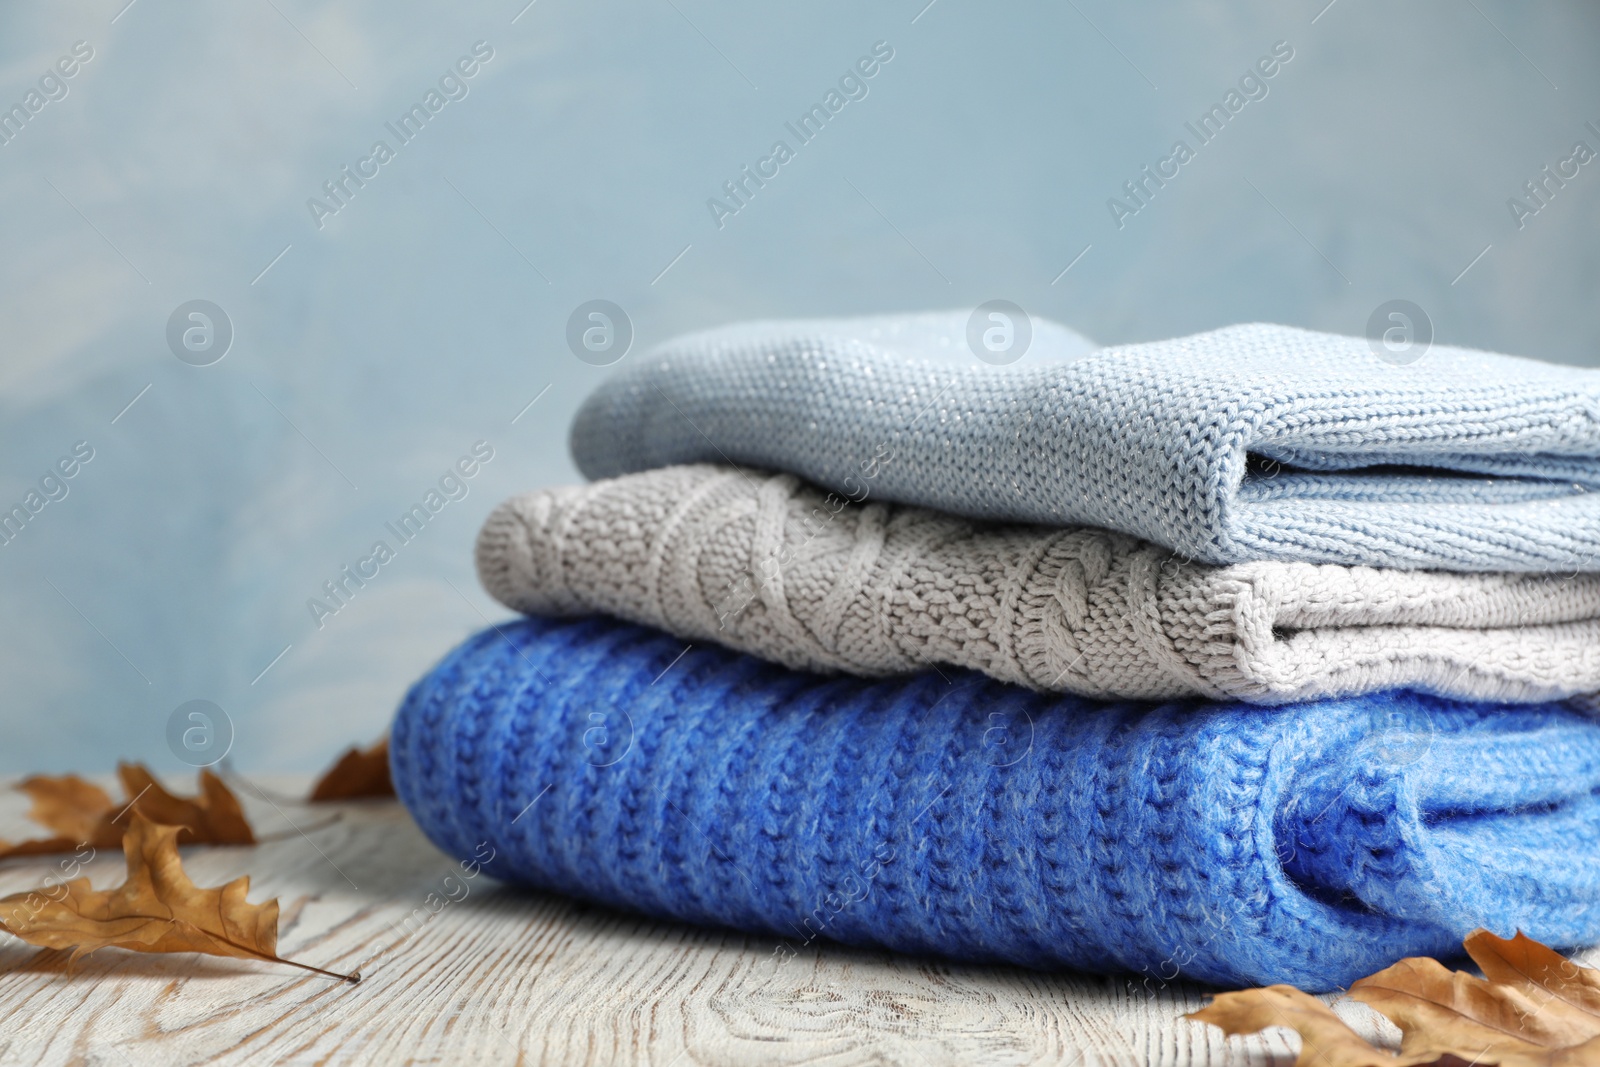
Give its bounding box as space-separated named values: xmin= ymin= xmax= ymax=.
xmin=571 ymin=316 xmax=1600 ymax=573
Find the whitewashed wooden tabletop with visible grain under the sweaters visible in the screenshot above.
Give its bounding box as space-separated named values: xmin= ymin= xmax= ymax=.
xmin=0 ymin=779 xmax=1387 ymax=1067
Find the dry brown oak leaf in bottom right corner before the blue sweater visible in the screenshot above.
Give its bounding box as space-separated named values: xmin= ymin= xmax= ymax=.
xmin=1189 ymin=929 xmax=1600 ymax=1067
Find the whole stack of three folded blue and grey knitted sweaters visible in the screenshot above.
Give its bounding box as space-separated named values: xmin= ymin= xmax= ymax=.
xmin=392 ymin=315 xmax=1600 ymax=990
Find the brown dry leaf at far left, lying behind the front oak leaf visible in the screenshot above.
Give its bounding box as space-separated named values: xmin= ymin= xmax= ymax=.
xmin=0 ymin=763 xmax=256 ymax=859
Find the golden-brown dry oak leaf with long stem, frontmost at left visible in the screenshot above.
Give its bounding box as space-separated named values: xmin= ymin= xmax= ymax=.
xmin=0 ymin=811 xmax=360 ymax=982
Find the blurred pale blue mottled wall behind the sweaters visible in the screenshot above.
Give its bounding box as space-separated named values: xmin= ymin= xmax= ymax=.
xmin=0 ymin=0 xmax=1600 ymax=773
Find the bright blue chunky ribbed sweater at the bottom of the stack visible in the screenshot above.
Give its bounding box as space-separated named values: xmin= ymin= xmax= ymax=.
xmin=390 ymin=617 xmax=1600 ymax=990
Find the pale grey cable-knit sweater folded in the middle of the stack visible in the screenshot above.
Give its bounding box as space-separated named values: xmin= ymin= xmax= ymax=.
xmin=477 ymin=466 xmax=1600 ymax=704
